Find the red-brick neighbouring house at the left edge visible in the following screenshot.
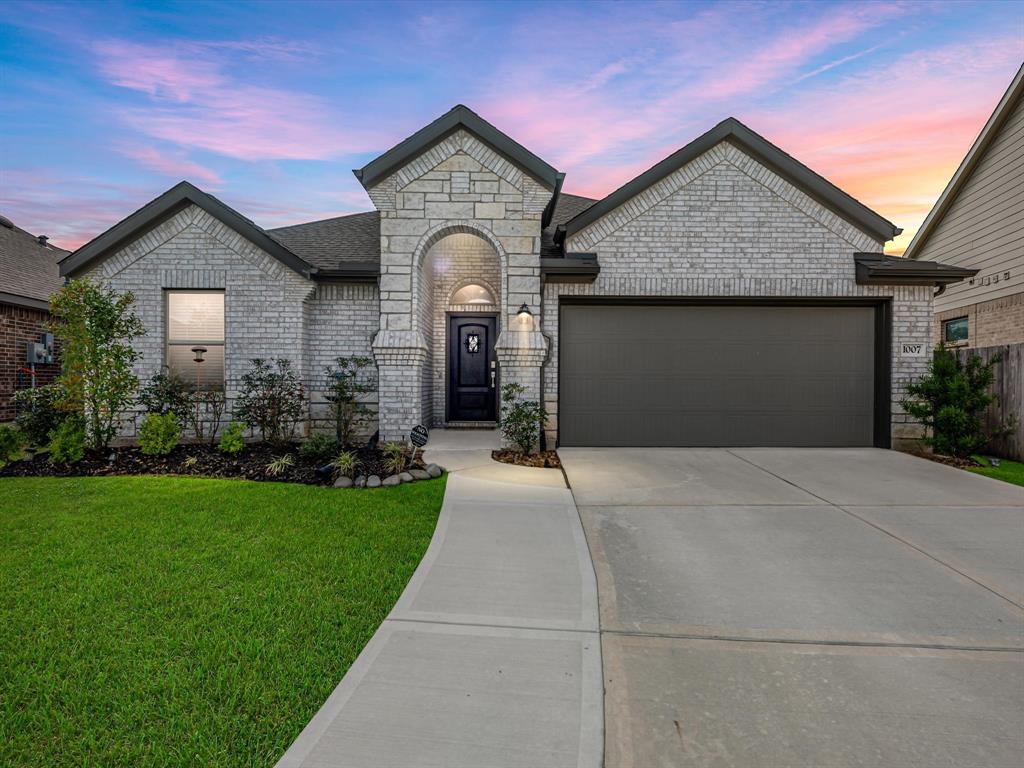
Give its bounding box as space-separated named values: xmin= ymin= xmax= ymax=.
xmin=0 ymin=216 xmax=68 ymax=424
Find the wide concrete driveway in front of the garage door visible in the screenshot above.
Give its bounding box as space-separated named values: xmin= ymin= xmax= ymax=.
xmin=559 ymin=449 xmax=1024 ymax=768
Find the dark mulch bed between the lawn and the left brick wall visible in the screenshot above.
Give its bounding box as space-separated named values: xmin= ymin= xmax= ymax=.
xmin=0 ymin=442 xmax=423 ymax=485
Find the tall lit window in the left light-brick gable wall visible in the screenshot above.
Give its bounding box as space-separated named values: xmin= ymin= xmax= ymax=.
xmin=166 ymin=291 xmax=224 ymax=389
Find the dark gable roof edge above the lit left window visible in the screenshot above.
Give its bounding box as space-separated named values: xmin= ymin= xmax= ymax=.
xmin=60 ymin=181 xmax=316 ymax=278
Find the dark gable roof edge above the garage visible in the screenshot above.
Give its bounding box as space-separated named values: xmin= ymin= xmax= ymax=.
xmin=558 ymin=118 xmax=902 ymax=246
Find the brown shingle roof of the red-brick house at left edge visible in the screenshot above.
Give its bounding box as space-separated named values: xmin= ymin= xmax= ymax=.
xmin=0 ymin=216 xmax=68 ymax=309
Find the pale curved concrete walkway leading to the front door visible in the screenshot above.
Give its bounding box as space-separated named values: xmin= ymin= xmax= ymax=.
xmin=278 ymin=431 xmax=603 ymax=768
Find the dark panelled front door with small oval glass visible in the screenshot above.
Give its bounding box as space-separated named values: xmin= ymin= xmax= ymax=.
xmin=447 ymin=314 xmax=498 ymax=421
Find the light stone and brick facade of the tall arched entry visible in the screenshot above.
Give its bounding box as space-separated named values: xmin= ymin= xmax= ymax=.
xmin=368 ymin=129 xmax=552 ymax=439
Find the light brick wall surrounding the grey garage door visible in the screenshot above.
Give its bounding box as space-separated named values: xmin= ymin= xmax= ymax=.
xmin=543 ymin=143 xmax=934 ymax=447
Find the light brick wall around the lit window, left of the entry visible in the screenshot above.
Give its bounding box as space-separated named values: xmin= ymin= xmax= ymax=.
xmin=88 ymin=205 xmax=378 ymax=436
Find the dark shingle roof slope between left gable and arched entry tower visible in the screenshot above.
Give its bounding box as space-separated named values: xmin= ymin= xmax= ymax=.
xmin=266 ymin=211 xmax=381 ymax=271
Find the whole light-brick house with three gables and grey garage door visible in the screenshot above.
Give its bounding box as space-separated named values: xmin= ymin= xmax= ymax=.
xmin=60 ymin=105 xmax=973 ymax=446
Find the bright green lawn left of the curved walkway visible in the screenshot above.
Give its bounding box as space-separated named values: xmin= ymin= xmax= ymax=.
xmin=0 ymin=477 xmax=444 ymax=767
